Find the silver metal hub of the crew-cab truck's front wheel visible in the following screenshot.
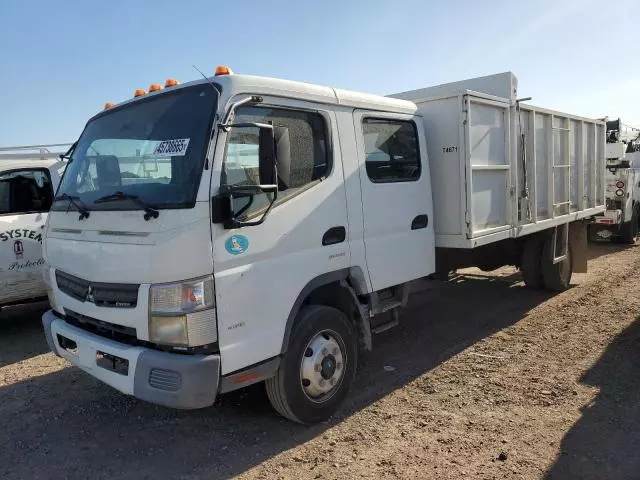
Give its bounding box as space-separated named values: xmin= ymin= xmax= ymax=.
xmin=300 ymin=330 xmax=344 ymax=402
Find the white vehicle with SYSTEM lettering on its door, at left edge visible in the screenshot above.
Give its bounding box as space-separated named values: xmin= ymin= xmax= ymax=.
xmin=0 ymin=144 xmax=70 ymax=309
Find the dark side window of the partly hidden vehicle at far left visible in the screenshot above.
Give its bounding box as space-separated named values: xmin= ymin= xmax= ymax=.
xmin=0 ymin=169 xmax=53 ymax=215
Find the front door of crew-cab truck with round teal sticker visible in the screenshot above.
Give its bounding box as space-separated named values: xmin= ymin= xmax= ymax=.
xmin=212 ymin=102 xmax=351 ymax=374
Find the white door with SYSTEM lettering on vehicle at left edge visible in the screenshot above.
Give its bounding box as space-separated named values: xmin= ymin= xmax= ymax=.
xmin=0 ymin=168 xmax=53 ymax=305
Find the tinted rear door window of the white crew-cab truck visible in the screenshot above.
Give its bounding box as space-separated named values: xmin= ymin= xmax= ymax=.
xmin=362 ymin=118 xmax=420 ymax=183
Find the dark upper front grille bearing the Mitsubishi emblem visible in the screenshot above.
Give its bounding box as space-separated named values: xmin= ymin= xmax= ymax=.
xmin=56 ymin=270 xmax=140 ymax=308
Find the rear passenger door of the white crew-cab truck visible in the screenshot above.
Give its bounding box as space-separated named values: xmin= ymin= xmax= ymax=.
xmin=354 ymin=111 xmax=435 ymax=291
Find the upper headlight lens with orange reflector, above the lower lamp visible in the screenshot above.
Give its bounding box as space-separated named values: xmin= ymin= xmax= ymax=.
xmin=149 ymin=276 xmax=215 ymax=315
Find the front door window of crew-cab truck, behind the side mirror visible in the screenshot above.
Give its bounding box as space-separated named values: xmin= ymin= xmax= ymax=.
xmin=222 ymin=107 xmax=329 ymax=220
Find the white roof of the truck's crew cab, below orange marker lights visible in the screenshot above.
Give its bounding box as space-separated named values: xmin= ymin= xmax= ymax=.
xmin=102 ymin=74 xmax=417 ymax=116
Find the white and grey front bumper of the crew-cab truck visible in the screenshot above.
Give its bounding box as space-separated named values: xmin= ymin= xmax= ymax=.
xmin=42 ymin=310 xmax=220 ymax=409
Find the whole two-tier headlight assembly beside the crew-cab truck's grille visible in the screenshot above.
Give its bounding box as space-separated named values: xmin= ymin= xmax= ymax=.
xmin=149 ymin=275 xmax=218 ymax=347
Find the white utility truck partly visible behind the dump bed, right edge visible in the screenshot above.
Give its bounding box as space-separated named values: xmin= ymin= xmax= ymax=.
xmin=589 ymin=119 xmax=640 ymax=244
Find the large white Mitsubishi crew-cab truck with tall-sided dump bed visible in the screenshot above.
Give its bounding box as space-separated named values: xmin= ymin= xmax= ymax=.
xmin=42 ymin=67 xmax=605 ymax=424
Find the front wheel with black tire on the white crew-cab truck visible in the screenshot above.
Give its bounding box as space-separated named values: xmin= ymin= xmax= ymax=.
xmin=265 ymin=305 xmax=358 ymax=425
